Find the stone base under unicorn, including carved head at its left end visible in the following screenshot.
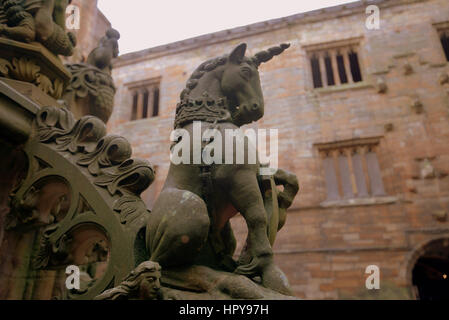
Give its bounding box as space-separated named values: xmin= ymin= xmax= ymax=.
xmin=95 ymin=261 xmax=296 ymax=300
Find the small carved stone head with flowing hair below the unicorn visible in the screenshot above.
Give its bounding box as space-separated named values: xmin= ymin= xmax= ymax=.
xmin=95 ymin=261 xmax=161 ymax=300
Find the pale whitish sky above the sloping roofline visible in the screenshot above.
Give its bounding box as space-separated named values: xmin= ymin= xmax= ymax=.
xmin=98 ymin=0 xmax=354 ymax=54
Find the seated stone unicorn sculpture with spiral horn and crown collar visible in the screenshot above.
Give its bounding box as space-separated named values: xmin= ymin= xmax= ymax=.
xmin=146 ymin=44 xmax=298 ymax=295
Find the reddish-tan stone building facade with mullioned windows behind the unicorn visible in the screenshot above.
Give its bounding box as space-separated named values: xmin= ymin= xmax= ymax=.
xmin=108 ymin=0 xmax=449 ymax=299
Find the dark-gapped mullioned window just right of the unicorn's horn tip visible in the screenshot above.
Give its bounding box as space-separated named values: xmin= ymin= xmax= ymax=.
xmin=305 ymin=40 xmax=363 ymax=89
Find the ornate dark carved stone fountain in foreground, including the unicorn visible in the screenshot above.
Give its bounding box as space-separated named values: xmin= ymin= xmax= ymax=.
xmin=0 ymin=0 xmax=299 ymax=299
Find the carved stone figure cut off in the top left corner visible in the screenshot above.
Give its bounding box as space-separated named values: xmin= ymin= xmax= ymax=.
xmin=0 ymin=0 xmax=76 ymax=56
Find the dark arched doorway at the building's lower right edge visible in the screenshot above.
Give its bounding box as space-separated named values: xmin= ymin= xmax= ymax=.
xmin=411 ymin=238 xmax=449 ymax=300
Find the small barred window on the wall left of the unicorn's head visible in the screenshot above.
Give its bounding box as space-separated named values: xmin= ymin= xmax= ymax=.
xmin=127 ymin=79 xmax=160 ymax=121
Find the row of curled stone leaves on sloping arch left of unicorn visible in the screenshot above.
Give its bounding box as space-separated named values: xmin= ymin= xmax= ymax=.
xmin=33 ymin=107 xmax=155 ymax=221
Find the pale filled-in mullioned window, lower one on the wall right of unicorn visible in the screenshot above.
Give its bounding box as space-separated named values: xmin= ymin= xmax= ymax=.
xmin=316 ymin=138 xmax=386 ymax=201
